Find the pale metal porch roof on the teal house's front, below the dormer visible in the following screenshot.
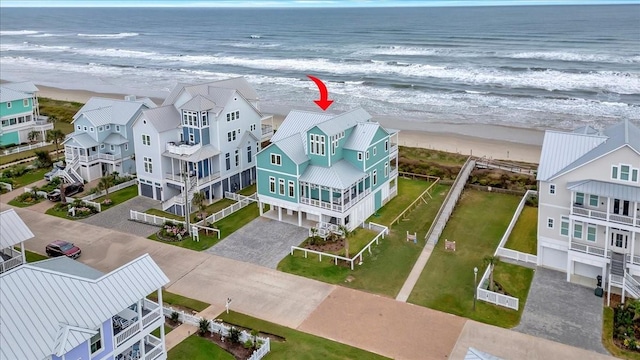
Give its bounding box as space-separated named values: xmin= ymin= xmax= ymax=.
xmin=300 ymin=160 xmax=367 ymax=189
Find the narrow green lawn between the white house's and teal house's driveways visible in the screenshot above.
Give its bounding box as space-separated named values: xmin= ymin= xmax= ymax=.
xmin=147 ymin=203 xmax=260 ymax=251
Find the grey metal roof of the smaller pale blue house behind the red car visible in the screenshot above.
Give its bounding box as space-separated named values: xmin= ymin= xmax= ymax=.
xmin=72 ymin=97 xmax=154 ymax=126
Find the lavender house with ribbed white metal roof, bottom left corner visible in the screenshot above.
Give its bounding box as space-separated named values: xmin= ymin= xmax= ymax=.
xmin=0 ymin=254 xmax=169 ymax=360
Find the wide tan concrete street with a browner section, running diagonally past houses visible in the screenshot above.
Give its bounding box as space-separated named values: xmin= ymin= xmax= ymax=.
xmin=0 ymin=204 xmax=607 ymax=360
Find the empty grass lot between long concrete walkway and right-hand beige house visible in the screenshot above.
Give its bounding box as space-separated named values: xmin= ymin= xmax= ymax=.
xmin=408 ymin=190 xmax=533 ymax=328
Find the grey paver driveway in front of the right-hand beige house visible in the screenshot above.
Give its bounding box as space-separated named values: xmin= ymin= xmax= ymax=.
xmin=514 ymin=267 xmax=608 ymax=354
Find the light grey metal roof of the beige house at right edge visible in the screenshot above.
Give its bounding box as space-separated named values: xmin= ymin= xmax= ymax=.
xmin=537 ymin=119 xmax=640 ymax=181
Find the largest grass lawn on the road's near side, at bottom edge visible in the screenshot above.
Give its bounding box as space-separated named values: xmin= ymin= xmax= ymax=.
xmin=220 ymin=311 xmax=386 ymax=360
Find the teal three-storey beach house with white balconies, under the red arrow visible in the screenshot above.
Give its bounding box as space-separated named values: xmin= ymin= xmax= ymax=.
xmin=257 ymin=108 xmax=398 ymax=229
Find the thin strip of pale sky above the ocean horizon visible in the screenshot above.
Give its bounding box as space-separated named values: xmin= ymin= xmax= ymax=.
xmin=0 ymin=0 xmax=640 ymax=8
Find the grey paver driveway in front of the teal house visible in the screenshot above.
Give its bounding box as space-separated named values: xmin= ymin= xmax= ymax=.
xmin=206 ymin=217 xmax=309 ymax=269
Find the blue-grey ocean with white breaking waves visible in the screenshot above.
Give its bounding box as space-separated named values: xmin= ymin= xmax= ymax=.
xmin=0 ymin=5 xmax=640 ymax=129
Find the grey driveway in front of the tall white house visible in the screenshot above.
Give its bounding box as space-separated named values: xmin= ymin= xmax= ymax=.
xmin=79 ymin=196 xmax=160 ymax=237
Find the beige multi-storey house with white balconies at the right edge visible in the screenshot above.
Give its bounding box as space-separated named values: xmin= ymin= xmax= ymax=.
xmin=537 ymin=120 xmax=640 ymax=297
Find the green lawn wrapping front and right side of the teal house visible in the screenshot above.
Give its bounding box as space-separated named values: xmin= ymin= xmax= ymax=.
xmin=278 ymin=179 xmax=449 ymax=297
